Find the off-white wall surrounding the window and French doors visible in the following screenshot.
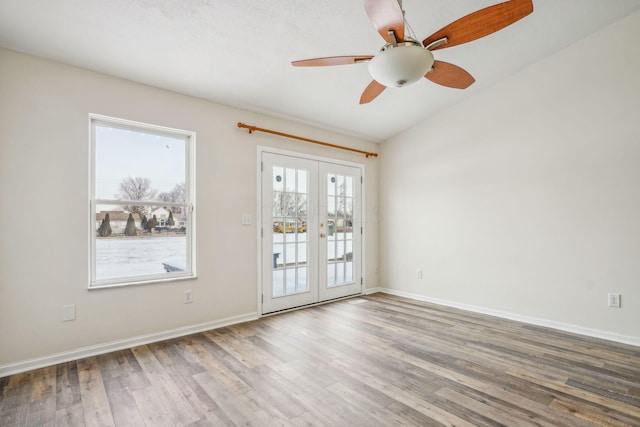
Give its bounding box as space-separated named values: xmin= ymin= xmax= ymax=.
xmin=0 ymin=50 xmax=379 ymax=372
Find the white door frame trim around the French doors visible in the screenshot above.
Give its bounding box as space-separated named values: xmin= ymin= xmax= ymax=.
xmin=256 ymin=145 xmax=367 ymax=317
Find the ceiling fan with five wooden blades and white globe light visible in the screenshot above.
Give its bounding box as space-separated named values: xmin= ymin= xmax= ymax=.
xmin=291 ymin=0 xmax=533 ymax=104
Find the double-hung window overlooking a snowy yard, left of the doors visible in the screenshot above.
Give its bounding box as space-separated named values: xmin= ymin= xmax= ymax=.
xmin=89 ymin=115 xmax=195 ymax=288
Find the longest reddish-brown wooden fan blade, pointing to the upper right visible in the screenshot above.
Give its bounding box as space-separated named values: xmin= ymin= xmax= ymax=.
xmin=422 ymin=0 xmax=533 ymax=50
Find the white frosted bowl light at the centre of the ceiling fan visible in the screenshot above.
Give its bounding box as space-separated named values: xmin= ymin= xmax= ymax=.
xmin=369 ymin=42 xmax=434 ymax=87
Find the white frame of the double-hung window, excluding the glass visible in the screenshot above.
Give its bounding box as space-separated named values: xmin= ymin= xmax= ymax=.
xmin=88 ymin=113 xmax=197 ymax=289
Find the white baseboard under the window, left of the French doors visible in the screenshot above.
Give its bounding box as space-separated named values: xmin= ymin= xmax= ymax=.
xmin=0 ymin=313 xmax=259 ymax=378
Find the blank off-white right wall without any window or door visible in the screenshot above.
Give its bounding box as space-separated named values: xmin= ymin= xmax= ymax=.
xmin=379 ymin=12 xmax=640 ymax=345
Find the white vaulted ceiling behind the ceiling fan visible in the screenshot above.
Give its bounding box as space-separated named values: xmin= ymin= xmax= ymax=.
xmin=0 ymin=0 xmax=640 ymax=141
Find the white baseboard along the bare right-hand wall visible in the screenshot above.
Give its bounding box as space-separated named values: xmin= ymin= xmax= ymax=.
xmin=378 ymin=288 xmax=640 ymax=347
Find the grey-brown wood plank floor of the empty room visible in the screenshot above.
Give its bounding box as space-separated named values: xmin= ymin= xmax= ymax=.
xmin=0 ymin=294 xmax=640 ymax=426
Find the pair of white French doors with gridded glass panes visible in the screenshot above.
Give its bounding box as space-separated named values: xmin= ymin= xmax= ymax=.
xmin=260 ymin=152 xmax=362 ymax=314
